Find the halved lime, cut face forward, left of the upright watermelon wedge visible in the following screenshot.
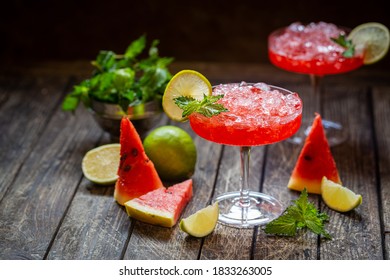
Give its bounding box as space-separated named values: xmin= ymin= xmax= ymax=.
xmin=81 ymin=143 xmax=121 ymax=185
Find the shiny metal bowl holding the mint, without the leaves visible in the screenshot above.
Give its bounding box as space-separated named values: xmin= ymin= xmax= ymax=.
xmin=90 ymin=100 xmax=162 ymax=140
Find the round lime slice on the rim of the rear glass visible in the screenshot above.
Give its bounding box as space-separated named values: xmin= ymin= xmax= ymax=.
xmin=348 ymin=22 xmax=390 ymax=64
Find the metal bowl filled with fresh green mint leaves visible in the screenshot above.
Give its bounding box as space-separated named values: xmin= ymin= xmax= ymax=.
xmin=62 ymin=35 xmax=173 ymax=138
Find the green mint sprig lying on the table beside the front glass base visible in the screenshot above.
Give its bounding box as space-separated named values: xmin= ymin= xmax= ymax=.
xmin=264 ymin=189 xmax=332 ymax=239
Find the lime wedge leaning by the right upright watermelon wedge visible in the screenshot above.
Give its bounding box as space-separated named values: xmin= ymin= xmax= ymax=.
xmin=321 ymin=177 xmax=362 ymax=212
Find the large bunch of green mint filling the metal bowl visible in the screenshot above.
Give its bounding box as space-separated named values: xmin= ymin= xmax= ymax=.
xmin=62 ymin=35 xmax=173 ymax=112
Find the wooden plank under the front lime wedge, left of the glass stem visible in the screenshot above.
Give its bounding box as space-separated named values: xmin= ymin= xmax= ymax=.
xmin=124 ymin=123 xmax=221 ymax=259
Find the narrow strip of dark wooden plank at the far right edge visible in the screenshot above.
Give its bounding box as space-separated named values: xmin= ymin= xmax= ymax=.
xmin=373 ymin=86 xmax=390 ymax=232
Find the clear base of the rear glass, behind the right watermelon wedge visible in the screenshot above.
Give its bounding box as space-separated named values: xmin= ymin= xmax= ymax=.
xmin=287 ymin=120 xmax=348 ymax=147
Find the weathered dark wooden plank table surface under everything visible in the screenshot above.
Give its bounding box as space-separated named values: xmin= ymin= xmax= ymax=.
xmin=0 ymin=61 xmax=390 ymax=260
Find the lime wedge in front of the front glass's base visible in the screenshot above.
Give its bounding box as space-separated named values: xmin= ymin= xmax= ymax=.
xmin=180 ymin=202 xmax=219 ymax=237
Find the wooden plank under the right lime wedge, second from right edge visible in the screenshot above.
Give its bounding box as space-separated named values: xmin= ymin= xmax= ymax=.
xmin=320 ymin=84 xmax=383 ymax=259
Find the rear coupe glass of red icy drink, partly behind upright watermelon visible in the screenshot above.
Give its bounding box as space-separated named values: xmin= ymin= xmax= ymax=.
xmin=268 ymin=22 xmax=363 ymax=146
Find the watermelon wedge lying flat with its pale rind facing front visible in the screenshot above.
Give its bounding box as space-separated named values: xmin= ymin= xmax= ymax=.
xmin=125 ymin=179 xmax=192 ymax=227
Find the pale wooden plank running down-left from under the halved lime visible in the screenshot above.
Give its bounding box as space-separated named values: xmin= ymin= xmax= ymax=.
xmin=47 ymin=114 xmax=167 ymax=260
